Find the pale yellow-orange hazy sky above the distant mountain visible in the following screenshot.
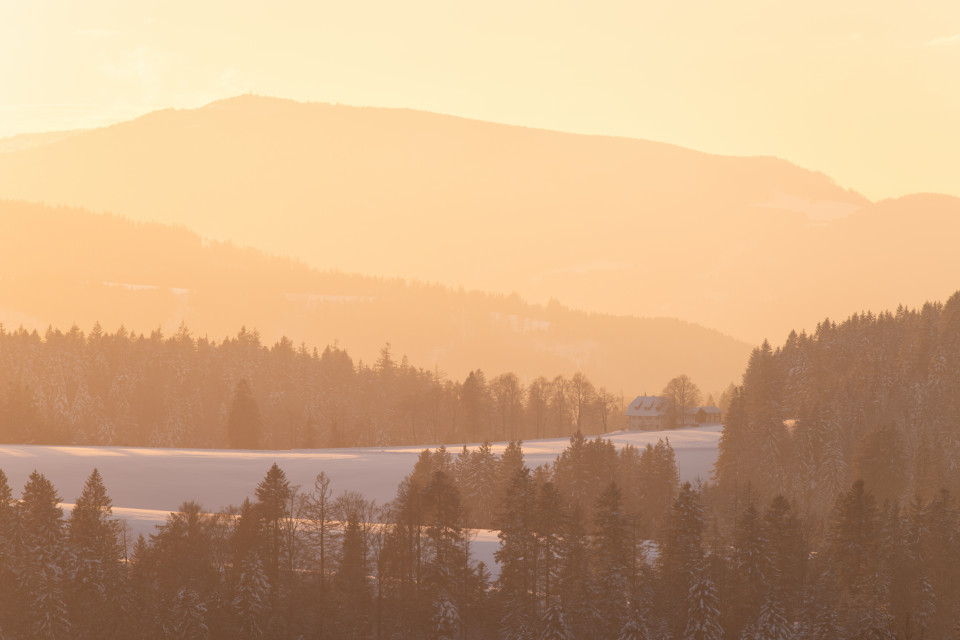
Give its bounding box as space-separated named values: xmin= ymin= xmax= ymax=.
xmin=0 ymin=0 xmax=960 ymax=199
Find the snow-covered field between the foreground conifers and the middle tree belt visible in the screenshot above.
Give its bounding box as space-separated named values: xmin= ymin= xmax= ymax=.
xmin=0 ymin=425 xmax=722 ymax=568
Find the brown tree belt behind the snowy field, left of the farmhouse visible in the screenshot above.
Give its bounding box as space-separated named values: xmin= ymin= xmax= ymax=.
xmin=0 ymin=325 xmax=623 ymax=449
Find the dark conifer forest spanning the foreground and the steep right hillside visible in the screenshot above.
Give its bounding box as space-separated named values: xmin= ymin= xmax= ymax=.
xmin=0 ymin=294 xmax=960 ymax=640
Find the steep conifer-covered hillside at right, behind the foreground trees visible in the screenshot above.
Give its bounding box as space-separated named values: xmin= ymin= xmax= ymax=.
xmin=717 ymin=293 xmax=960 ymax=517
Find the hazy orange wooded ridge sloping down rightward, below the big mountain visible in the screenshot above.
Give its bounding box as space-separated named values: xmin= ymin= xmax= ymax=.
xmin=0 ymin=200 xmax=749 ymax=397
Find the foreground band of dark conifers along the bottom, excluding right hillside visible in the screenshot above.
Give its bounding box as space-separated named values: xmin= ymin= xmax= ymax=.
xmin=0 ymin=434 xmax=960 ymax=640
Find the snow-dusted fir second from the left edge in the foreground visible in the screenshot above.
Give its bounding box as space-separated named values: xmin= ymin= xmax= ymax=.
xmin=16 ymin=471 xmax=70 ymax=640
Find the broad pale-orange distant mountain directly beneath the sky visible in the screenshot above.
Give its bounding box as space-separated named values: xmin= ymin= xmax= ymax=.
xmin=0 ymin=96 xmax=960 ymax=342
